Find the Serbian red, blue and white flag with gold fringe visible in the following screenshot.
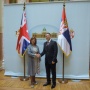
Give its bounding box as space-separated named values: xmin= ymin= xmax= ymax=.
xmin=57 ymin=5 xmax=72 ymax=56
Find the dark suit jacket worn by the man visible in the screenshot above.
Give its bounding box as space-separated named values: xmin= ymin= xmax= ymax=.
xmin=40 ymin=40 xmax=58 ymax=64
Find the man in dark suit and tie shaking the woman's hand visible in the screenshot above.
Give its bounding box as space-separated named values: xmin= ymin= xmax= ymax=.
xmin=37 ymin=33 xmax=58 ymax=88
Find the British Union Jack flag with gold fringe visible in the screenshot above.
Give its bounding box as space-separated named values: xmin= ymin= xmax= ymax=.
xmin=16 ymin=10 xmax=30 ymax=57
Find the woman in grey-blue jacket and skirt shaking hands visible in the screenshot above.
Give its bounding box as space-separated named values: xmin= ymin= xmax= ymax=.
xmin=28 ymin=37 xmax=40 ymax=87
